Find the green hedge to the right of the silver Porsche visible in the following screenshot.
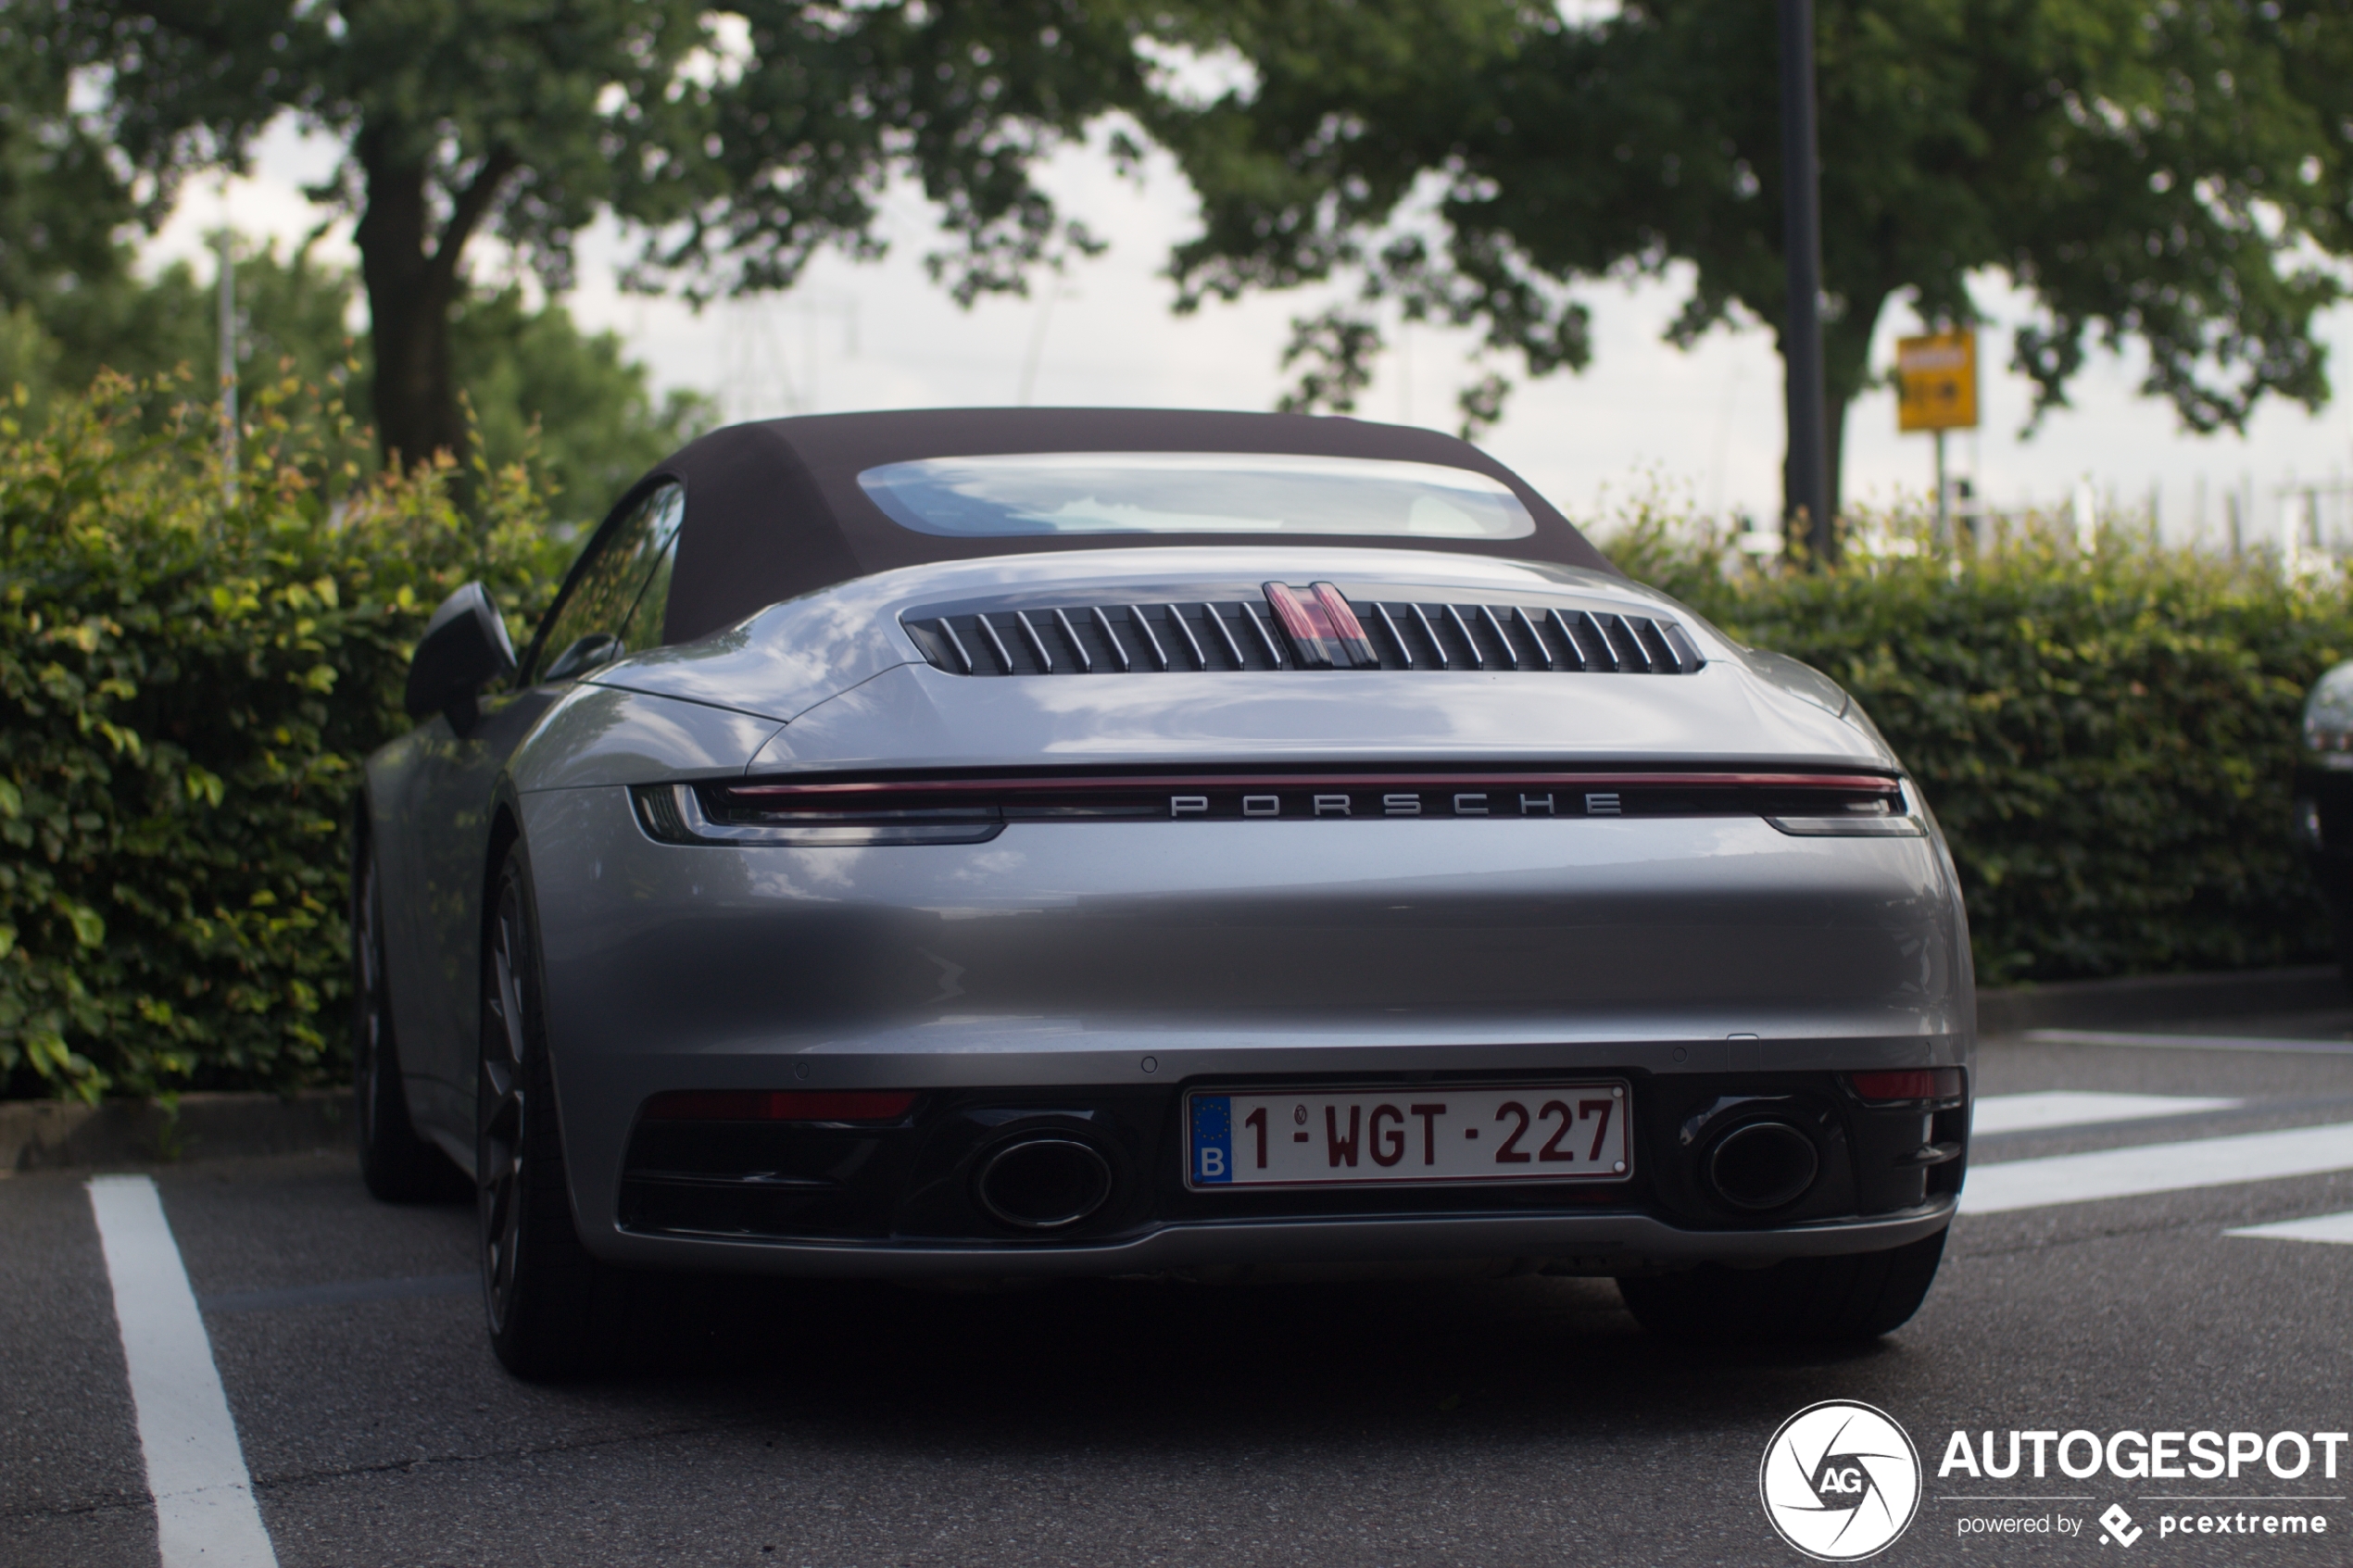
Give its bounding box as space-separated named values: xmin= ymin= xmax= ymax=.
xmin=1619 ymin=515 xmax=2353 ymax=985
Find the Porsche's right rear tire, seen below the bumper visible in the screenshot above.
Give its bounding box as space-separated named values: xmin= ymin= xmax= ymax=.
xmin=1617 ymin=1229 xmax=1946 ymax=1345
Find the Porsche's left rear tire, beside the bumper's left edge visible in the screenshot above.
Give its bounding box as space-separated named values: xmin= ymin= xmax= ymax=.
xmin=475 ymin=844 xmax=631 ymax=1382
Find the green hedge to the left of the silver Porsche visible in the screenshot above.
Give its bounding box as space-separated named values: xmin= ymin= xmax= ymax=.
xmin=0 ymin=379 xmax=562 ymax=1100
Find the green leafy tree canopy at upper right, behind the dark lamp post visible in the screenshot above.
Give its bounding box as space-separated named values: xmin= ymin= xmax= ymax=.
xmin=1155 ymin=0 xmax=2353 ymax=521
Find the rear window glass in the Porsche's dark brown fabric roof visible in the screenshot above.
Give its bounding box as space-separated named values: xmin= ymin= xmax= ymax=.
xmin=859 ymin=451 xmax=1537 ymax=538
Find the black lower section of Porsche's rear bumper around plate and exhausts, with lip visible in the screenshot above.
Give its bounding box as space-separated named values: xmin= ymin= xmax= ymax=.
xmin=581 ymin=1070 xmax=1967 ymax=1276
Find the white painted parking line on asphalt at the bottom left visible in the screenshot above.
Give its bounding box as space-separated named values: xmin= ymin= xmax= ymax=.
xmin=90 ymin=1175 xmax=278 ymax=1568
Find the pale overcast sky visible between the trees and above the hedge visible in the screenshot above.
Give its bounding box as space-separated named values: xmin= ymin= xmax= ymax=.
xmin=151 ymin=115 xmax=2353 ymax=552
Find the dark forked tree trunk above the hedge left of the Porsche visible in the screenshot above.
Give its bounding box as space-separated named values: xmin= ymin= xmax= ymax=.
xmin=353 ymin=127 xmax=515 ymax=466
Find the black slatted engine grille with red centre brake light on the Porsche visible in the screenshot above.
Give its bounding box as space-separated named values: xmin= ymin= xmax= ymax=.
xmin=903 ymin=583 xmax=1706 ymax=674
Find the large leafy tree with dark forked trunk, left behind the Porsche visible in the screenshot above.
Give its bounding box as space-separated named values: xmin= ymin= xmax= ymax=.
xmin=67 ymin=0 xmax=1166 ymax=458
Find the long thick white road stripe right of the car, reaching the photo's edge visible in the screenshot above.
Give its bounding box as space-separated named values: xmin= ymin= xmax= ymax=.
xmin=1960 ymin=1122 xmax=2353 ymax=1213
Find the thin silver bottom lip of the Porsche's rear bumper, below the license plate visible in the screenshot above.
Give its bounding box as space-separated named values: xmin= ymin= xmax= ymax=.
xmin=596 ymin=1197 xmax=1956 ymax=1279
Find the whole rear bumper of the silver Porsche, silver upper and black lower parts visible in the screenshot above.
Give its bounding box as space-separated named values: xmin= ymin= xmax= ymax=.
xmin=522 ymin=787 xmax=1974 ymax=1276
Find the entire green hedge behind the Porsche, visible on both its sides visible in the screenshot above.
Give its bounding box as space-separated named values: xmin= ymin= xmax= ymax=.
xmin=0 ymin=381 xmax=2353 ymax=1098
